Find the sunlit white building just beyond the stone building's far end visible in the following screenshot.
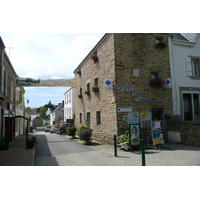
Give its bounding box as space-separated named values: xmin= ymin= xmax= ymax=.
xmin=64 ymin=87 xmax=76 ymax=122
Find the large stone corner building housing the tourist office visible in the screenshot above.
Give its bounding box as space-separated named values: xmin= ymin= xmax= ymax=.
xmin=74 ymin=33 xmax=172 ymax=143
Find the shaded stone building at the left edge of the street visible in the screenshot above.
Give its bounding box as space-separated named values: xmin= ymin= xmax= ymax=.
xmin=0 ymin=37 xmax=17 ymax=142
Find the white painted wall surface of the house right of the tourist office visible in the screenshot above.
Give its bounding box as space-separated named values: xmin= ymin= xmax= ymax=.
xmin=168 ymin=33 xmax=200 ymax=118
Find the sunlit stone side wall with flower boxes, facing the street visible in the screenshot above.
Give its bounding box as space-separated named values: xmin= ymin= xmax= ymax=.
xmin=75 ymin=34 xmax=117 ymax=143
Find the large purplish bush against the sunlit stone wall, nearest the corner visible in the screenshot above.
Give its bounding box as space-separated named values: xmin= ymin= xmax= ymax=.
xmin=79 ymin=125 xmax=93 ymax=144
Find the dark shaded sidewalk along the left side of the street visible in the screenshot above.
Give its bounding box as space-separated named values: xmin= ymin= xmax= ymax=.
xmin=0 ymin=135 xmax=35 ymax=166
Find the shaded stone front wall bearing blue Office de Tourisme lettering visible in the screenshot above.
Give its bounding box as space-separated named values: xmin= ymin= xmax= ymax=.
xmin=115 ymin=33 xmax=172 ymax=138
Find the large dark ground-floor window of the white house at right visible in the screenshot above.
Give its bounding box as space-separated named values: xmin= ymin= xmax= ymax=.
xmin=183 ymin=92 xmax=200 ymax=121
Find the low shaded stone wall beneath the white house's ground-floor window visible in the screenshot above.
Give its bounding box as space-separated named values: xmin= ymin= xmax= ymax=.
xmin=167 ymin=120 xmax=200 ymax=146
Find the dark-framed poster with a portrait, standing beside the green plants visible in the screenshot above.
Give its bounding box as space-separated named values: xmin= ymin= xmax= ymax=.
xmin=129 ymin=124 xmax=140 ymax=146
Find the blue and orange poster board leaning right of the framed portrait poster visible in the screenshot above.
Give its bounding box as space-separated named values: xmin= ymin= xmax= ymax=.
xmin=152 ymin=120 xmax=164 ymax=146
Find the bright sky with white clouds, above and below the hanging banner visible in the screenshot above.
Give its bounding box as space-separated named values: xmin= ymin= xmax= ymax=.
xmin=0 ymin=33 xmax=105 ymax=108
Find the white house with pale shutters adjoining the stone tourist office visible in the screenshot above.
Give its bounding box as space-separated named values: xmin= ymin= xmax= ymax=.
xmin=169 ymin=33 xmax=200 ymax=121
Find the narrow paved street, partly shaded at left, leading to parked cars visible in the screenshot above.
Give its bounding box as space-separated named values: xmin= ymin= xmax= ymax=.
xmin=34 ymin=132 xmax=127 ymax=166
